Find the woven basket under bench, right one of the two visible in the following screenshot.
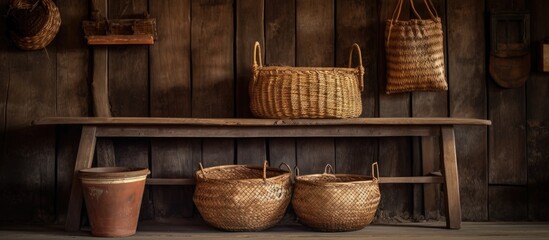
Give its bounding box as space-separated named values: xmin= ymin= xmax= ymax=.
xmin=292 ymin=163 xmax=381 ymax=232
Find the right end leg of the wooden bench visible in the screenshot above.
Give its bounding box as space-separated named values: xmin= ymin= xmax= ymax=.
xmin=441 ymin=126 xmax=461 ymax=229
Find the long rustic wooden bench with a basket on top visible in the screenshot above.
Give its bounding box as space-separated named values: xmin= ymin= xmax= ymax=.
xmin=34 ymin=117 xmax=491 ymax=231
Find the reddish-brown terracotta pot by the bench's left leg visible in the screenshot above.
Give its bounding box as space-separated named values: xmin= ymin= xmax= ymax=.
xmin=79 ymin=167 xmax=150 ymax=237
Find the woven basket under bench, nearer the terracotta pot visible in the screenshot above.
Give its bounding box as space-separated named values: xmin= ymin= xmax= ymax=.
xmin=193 ymin=161 xmax=292 ymax=231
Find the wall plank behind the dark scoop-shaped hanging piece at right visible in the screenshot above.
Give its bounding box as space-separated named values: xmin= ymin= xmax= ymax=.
xmin=486 ymin=0 xmax=527 ymax=186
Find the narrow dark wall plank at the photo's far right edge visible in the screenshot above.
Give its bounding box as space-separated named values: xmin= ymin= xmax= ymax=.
xmin=526 ymin=0 xmax=549 ymax=221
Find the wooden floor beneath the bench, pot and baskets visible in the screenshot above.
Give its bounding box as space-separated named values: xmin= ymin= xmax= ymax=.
xmin=0 ymin=222 xmax=549 ymax=240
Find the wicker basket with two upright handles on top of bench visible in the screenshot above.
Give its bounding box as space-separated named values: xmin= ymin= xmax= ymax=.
xmin=249 ymin=42 xmax=364 ymax=118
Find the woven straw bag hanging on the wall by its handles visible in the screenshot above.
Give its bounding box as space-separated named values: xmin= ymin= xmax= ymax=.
xmin=385 ymin=0 xmax=448 ymax=94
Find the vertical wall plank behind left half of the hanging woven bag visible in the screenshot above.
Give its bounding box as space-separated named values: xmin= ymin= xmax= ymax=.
xmin=378 ymin=0 xmax=413 ymax=221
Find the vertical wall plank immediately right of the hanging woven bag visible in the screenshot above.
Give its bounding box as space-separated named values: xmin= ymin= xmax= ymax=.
xmin=446 ymin=0 xmax=488 ymax=221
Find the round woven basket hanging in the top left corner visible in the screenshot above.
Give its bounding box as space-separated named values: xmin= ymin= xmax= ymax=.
xmin=8 ymin=0 xmax=61 ymax=50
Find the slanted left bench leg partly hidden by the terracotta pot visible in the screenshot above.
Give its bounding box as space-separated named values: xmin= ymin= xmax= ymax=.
xmin=65 ymin=125 xmax=97 ymax=231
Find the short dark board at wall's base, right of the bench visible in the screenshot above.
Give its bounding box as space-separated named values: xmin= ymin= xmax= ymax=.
xmin=488 ymin=185 xmax=528 ymax=221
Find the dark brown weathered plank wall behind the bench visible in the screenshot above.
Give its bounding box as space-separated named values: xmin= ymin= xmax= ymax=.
xmin=0 ymin=0 xmax=549 ymax=224
